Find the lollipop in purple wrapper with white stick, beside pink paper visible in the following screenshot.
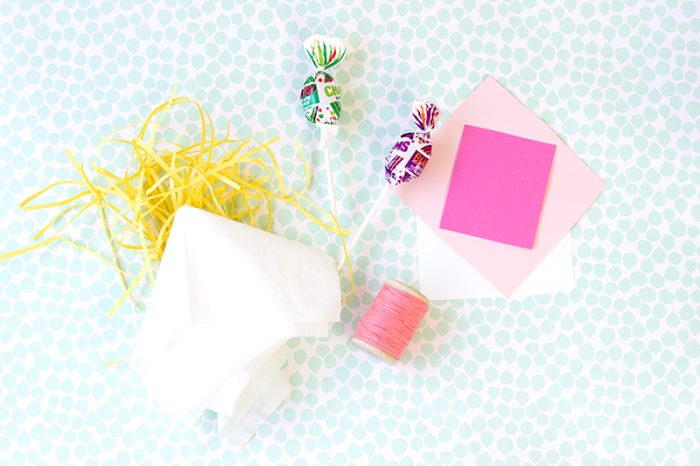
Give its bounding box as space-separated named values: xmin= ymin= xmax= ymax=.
xmin=338 ymin=100 xmax=440 ymax=267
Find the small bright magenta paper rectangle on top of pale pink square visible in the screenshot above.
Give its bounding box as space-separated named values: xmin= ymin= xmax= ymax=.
xmin=440 ymin=125 xmax=556 ymax=248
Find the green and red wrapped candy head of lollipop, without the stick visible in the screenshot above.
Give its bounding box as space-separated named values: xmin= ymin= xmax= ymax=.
xmin=301 ymin=34 xmax=347 ymax=125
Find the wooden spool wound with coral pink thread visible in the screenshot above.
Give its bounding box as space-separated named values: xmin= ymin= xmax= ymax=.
xmin=352 ymin=279 xmax=429 ymax=363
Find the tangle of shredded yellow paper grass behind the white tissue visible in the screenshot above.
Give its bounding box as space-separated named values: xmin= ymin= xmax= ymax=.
xmin=0 ymin=97 xmax=352 ymax=316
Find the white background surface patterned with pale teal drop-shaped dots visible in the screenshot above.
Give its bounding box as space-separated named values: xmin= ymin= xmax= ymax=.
xmin=0 ymin=0 xmax=700 ymax=465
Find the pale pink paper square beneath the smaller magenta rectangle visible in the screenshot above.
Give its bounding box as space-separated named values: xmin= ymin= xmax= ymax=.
xmin=396 ymin=76 xmax=604 ymax=297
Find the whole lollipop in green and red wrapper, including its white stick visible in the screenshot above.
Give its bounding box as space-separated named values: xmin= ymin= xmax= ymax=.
xmin=301 ymin=34 xmax=347 ymax=220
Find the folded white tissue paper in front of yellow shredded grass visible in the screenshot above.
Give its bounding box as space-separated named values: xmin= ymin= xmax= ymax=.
xmin=132 ymin=207 xmax=341 ymax=445
